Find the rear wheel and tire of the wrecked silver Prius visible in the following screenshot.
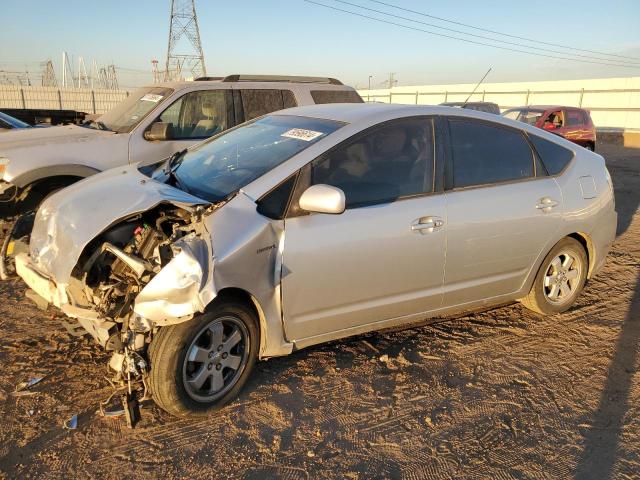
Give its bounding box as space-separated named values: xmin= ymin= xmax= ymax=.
xmin=520 ymin=237 xmax=589 ymax=315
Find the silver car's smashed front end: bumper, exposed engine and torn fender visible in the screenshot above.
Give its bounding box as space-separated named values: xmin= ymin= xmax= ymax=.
xmin=17 ymin=205 xmax=213 ymax=379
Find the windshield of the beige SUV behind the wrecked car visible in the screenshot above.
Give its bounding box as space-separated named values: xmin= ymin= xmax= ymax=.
xmin=96 ymin=87 xmax=173 ymax=133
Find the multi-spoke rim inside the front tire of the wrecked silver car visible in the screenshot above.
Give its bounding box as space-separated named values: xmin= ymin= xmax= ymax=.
xmin=182 ymin=317 xmax=249 ymax=402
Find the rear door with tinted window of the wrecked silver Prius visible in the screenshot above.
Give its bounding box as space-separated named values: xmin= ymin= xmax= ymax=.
xmin=444 ymin=118 xmax=562 ymax=306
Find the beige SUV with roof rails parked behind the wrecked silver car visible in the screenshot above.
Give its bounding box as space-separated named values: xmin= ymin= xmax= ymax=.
xmin=0 ymin=75 xmax=362 ymax=214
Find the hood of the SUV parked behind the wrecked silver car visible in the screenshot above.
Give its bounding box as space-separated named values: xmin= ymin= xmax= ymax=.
xmin=0 ymin=125 xmax=114 ymax=154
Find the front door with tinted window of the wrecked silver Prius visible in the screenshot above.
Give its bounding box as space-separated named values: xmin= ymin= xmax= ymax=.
xmin=282 ymin=117 xmax=446 ymax=340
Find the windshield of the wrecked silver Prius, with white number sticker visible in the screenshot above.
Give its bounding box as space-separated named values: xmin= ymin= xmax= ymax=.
xmin=152 ymin=115 xmax=343 ymax=202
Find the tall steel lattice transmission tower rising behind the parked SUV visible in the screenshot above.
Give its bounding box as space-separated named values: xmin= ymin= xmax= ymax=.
xmin=165 ymin=0 xmax=207 ymax=80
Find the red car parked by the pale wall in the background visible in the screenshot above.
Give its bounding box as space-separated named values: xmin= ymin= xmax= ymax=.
xmin=502 ymin=105 xmax=596 ymax=151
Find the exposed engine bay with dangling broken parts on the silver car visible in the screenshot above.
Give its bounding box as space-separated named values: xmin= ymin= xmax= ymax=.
xmin=66 ymin=205 xmax=204 ymax=423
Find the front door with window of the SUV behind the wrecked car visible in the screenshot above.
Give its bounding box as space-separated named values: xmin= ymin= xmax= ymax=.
xmin=129 ymin=89 xmax=235 ymax=163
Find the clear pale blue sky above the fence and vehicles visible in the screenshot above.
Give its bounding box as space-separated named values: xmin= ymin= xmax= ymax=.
xmin=0 ymin=0 xmax=640 ymax=88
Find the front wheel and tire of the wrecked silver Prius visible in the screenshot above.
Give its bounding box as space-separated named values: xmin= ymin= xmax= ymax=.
xmin=148 ymin=302 xmax=260 ymax=416
